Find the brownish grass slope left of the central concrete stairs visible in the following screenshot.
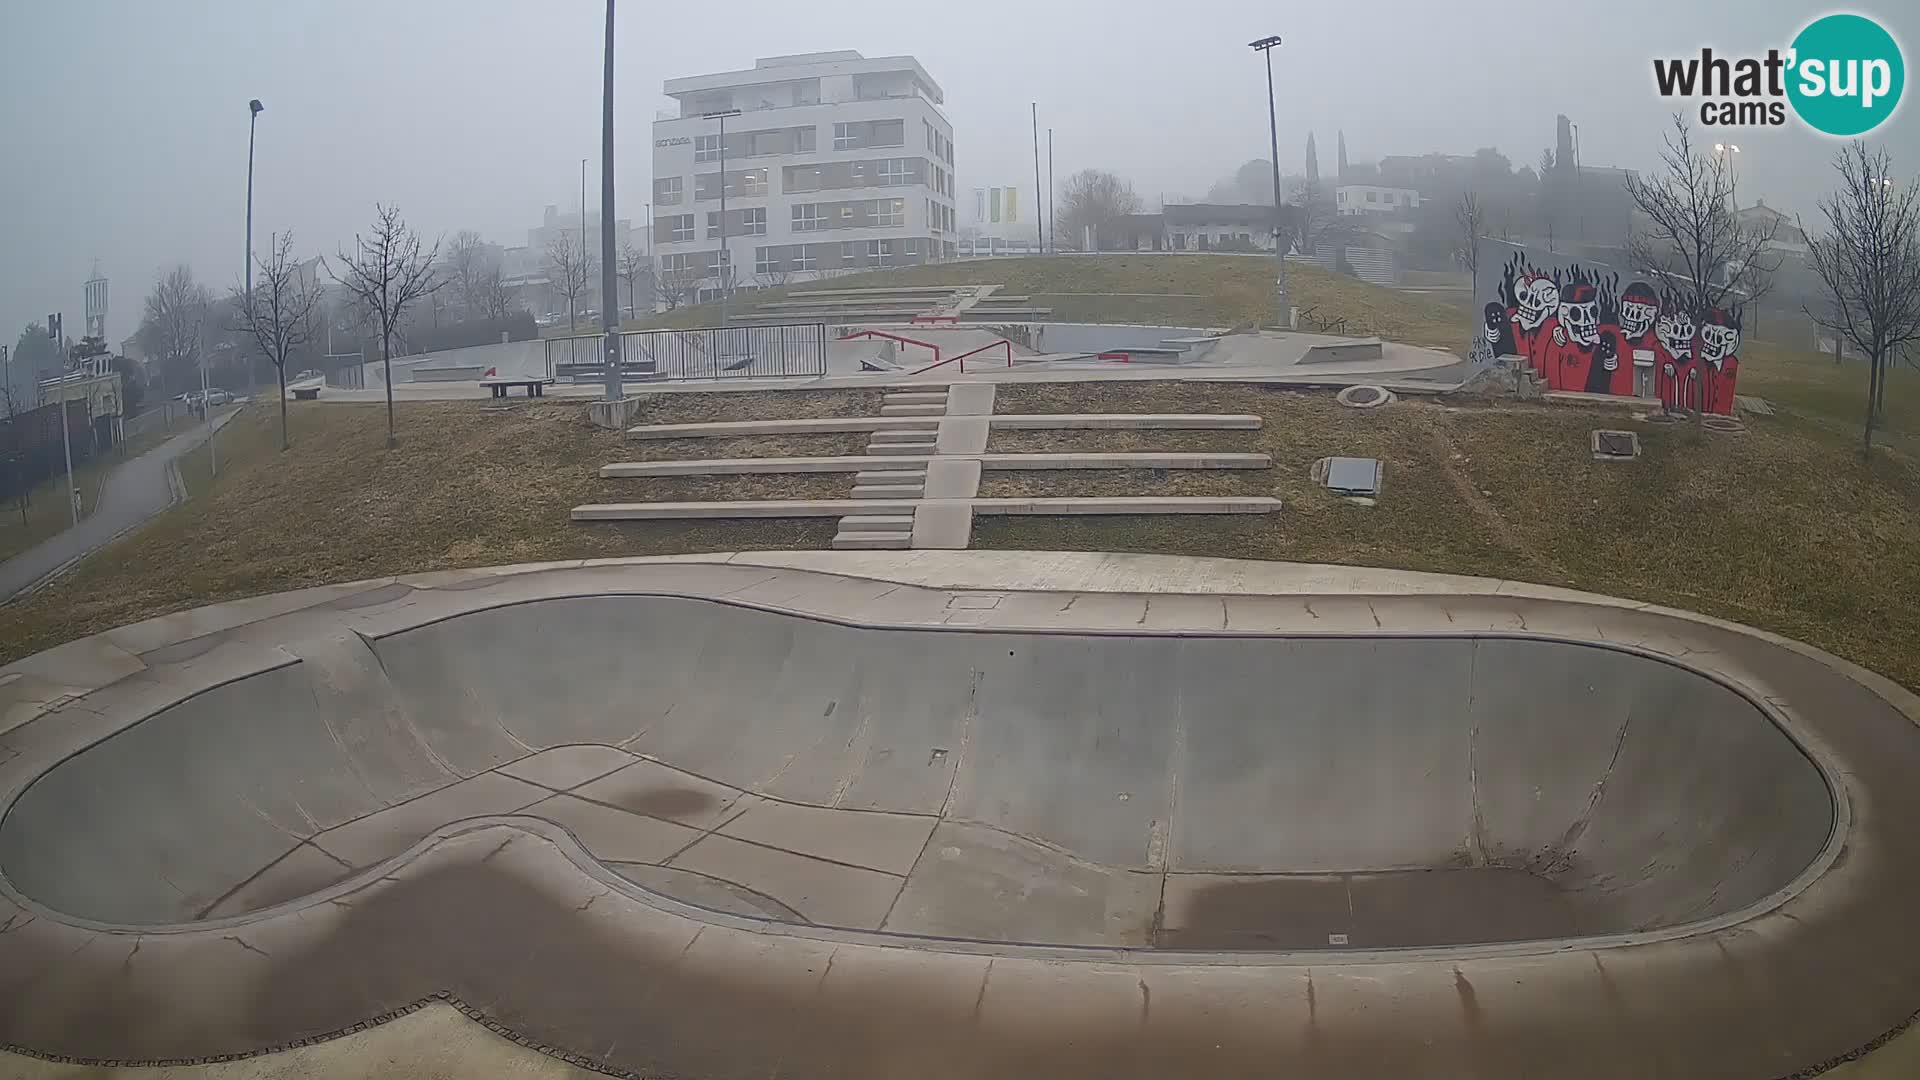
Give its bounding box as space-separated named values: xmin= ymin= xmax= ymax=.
xmin=0 ymin=392 xmax=866 ymax=663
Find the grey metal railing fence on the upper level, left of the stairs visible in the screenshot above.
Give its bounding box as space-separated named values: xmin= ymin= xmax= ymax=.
xmin=547 ymin=323 xmax=828 ymax=382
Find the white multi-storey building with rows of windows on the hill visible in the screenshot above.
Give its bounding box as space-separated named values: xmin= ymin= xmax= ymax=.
xmin=653 ymin=52 xmax=958 ymax=296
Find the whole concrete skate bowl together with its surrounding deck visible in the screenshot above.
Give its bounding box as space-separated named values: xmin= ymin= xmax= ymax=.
xmin=0 ymin=552 xmax=1920 ymax=1080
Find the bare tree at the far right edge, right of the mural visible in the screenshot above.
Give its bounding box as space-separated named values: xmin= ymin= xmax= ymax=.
xmin=1807 ymin=142 xmax=1920 ymax=454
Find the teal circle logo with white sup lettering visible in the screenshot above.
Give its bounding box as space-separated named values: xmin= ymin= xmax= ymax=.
xmin=1788 ymin=15 xmax=1907 ymax=136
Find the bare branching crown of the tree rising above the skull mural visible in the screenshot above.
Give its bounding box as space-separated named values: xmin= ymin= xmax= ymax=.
xmin=1626 ymin=113 xmax=1780 ymax=319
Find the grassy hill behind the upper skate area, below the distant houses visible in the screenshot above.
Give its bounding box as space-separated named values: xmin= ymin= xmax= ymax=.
xmin=636 ymin=256 xmax=1469 ymax=348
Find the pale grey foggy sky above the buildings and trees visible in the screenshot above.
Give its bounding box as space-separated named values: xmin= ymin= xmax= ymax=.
xmin=0 ymin=0 xmax=1920 ymax=346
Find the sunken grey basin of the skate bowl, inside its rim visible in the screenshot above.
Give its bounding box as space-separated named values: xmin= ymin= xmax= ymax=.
xmin=0 ymin=596 xmax=1843 ymax=953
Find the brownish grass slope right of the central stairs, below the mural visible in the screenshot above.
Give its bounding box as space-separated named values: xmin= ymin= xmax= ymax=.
xmin=975 ymin=382 xmax=1920 ymax=688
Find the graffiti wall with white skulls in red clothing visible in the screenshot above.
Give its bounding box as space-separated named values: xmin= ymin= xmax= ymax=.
xmin=1473 ymin=240 xmax=1741 ymax=413
